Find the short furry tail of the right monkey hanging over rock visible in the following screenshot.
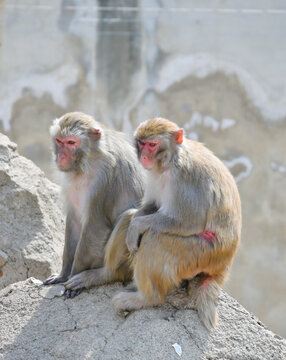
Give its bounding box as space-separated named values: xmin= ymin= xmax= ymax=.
xmin=188 ymin=274 xmax=221 ymax=330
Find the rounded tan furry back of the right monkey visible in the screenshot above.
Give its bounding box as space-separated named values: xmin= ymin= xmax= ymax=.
xmin=179 ymin=139 xmax=241 ymax=242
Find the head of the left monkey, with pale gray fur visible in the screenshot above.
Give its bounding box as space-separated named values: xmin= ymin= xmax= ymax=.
xmin=50 ymin=112 xmax=102 ymax=172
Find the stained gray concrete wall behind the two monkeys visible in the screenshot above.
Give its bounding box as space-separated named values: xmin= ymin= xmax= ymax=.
xmin=0 ymin=0 xmax=286 ymax=336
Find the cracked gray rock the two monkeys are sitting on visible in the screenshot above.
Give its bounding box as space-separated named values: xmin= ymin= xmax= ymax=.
xmin=0 ymin=279 xmax=286 ymax=360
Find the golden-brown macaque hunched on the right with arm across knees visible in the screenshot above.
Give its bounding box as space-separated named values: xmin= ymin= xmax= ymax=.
xmin=109 ymin=118 xmax=241 ymax=329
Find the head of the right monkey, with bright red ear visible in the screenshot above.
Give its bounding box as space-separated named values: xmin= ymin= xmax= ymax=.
xmin=134 ymin=117 xmax=183 ymax=170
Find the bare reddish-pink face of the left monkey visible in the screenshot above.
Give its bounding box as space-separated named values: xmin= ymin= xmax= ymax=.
xmin=54 ymin=136 xmax=81 ymax=171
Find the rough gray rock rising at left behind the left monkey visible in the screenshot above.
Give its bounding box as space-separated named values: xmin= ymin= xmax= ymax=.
xmin=0 ymin=134 xmax=64 ymax=289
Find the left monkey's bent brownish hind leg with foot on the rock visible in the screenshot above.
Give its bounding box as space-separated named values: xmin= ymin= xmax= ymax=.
xmin=65 ymin=209 xmax=136 ymax=297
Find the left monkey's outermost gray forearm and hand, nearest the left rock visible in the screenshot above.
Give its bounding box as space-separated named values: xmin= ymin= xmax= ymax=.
xmin=44 ymin=211 xmax=80 ymax=285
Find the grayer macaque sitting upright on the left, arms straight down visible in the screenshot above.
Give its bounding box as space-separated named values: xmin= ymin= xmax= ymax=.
xmin=44 ymin=112 xmax=143 ymax=297
